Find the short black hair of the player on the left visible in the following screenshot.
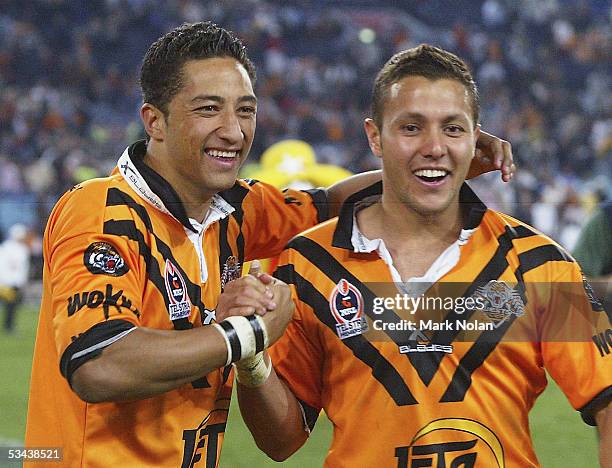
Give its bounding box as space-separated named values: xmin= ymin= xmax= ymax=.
xmin=140 ymin=21 xmax=256 ymax=117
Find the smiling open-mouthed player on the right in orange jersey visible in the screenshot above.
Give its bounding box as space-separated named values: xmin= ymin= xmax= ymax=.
xmin=238 ymin=45 xmax=612 ymax=468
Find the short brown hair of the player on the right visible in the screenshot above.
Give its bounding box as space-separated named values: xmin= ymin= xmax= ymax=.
xmin=372 ymin=44 xmax=480 ymax=128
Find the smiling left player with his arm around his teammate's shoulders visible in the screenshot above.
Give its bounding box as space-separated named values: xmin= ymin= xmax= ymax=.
xmin=26 ymin=23 xmax=512 ymax=468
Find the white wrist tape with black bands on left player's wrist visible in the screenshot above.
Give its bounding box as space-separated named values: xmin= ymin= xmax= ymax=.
xmin=214 ymin=315 xmax=269 ymax=366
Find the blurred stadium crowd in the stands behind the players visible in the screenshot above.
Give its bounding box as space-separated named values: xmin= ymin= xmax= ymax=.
xmin=0 ymin=0 xmax=612 ymax=248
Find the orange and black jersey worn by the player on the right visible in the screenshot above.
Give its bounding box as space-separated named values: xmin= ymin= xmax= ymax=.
xmin=269 ymin=184 xmax=612 ymax=468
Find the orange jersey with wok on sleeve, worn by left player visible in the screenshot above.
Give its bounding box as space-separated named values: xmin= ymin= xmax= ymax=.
xmin=25 ymin=142 xmax=327 ymax=467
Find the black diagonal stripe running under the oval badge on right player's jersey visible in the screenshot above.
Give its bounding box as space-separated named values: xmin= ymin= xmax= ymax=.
xmin=275 ymin=265 xmax=417 ymax=406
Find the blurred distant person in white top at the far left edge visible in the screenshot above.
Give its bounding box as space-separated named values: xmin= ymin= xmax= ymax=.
xmin=0 ymin=224 xmax=30 ymax=334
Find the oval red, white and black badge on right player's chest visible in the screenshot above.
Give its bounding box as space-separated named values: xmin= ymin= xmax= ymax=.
xmin=329 ymin=278 xmax=368 ymax=340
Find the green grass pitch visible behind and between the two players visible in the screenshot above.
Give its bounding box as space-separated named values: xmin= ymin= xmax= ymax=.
xmin=0 ymin=308 xmax=598 ymax=468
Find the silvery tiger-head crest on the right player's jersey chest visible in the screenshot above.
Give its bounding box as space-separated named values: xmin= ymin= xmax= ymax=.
xmin=473 ymin=280 xmax=525 ymax=328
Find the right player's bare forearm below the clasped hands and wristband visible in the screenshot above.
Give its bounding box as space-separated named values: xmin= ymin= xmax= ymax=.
xmin=237 ymin=356 xmax=308 ymax=461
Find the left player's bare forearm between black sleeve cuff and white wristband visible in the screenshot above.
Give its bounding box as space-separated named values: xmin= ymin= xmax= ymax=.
xmin=71 ymin=326 xmax=227 ymax=403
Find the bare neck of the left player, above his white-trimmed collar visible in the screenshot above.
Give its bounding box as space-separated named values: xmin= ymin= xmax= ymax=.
xmin=144 ymin=140 xmax=215 ymax=223
